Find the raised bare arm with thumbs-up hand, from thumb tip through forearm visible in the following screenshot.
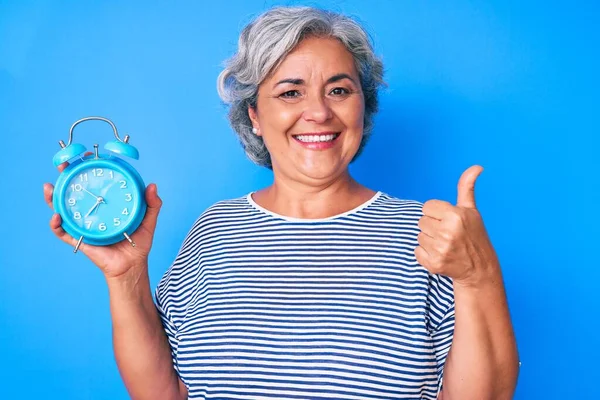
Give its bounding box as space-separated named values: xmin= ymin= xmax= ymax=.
xmin=415 ymin=166 xmax=518 ymax=399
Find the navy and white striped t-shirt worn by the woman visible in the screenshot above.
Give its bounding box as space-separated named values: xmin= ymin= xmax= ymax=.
xmin=156 ymin=192 xmax=454 ymax=400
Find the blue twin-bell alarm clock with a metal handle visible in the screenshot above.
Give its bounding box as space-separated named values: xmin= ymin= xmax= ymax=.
xmin=52 ymin=117 xmax=146 ymax=253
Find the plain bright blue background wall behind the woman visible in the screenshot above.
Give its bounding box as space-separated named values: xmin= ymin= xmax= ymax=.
xmin=0 ymin=0 xmax=600 ymax=400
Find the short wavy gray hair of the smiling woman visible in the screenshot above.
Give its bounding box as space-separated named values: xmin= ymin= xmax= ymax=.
xmin=217 ymin=7 xmax=384 ymax=168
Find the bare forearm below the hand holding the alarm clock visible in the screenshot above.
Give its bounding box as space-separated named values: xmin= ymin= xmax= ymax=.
xmin=107 ymin=266 xmax=185 ymax=400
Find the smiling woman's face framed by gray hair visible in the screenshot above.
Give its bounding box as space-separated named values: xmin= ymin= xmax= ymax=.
xmin=248 ymin=38 xmax=365 ymax=185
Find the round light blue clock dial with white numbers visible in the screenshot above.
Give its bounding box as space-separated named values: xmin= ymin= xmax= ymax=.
xmin=63 ymin=165 xmax=139 ymax=238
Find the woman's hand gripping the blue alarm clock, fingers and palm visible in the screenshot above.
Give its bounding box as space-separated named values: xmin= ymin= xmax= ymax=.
xmin=44 ymin=159 xmax=162 ymax=279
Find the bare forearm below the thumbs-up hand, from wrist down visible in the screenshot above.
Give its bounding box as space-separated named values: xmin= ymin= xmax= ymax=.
xmin=443 ymin=267 xmax=518 ymax=400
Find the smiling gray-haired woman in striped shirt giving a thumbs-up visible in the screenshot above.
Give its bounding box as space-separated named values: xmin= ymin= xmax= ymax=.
xmin=45 ymin=7 xmax=517 ymax=400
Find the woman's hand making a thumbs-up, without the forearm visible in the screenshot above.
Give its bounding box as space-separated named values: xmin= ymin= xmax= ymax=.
xmin=415 ymin=165 xmax=499 ymax=286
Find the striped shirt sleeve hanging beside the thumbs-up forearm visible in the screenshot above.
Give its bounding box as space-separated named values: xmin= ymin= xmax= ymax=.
xmin=427 ymin=275 xmax=454 ymax=390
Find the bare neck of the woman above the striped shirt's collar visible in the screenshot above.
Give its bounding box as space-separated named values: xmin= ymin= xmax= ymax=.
xmin=253 ymin=171 xmax=375 ymax=219
